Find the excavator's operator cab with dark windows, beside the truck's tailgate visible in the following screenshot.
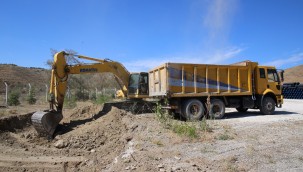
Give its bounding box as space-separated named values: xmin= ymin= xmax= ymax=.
xmin=128 ymin=72 xmax=149 ymax=98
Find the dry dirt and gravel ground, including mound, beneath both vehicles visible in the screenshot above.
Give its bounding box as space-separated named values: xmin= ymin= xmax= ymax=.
xmin=0 ymin=100 xmax=303 ymax=172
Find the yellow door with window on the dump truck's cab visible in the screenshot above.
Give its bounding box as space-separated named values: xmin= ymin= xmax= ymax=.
xmin=267 ymin=69 xmax=281 ymax=95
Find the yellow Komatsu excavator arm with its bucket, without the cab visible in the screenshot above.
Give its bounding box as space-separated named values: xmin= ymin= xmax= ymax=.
xmin=31 ymin=51 xmax=130 ymax=137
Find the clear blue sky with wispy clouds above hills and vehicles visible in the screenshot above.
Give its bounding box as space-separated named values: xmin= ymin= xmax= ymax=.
xmin=0 ymin=0 xmax=303 ymax=72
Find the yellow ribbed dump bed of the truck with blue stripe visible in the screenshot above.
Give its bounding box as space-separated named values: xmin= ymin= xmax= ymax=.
xmin=149 ymin=62 xmax=257 ymax=97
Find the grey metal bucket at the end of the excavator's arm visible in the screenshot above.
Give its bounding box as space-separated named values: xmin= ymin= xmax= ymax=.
xmin=31 ymin=111 xmax=63 ymax=138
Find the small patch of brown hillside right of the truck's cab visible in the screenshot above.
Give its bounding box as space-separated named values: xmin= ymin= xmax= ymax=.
xmin=284 ymin=65 xmax=303 ymax=83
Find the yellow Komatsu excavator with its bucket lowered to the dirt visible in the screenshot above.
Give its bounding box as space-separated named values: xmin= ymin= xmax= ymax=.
xmin=31 ymin=51 xmax=149 ymax=137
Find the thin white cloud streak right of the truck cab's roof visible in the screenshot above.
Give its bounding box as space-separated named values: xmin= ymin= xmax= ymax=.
xmin=264 ymin=52 xmax=303 ymax=68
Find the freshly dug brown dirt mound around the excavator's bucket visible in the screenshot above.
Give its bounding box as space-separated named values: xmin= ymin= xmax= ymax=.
xmin=0 ymin=105 xmax=140 ymax=171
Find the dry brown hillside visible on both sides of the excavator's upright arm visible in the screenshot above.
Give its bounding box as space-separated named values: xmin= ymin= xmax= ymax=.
xmin=0 ymin=64 xmax=119 ymax=98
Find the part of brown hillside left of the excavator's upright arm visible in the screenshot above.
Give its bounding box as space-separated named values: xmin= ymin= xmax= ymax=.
xmin=0 ymin=64 xmax=50 ymax=93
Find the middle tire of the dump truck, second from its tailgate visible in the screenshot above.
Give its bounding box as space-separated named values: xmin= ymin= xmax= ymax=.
xmin=209 ymin=99 xmax=225 ymax=119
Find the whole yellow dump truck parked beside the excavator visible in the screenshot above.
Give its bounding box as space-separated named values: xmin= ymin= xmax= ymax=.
xmin=149 ymin=61 xmax=283 ymax=120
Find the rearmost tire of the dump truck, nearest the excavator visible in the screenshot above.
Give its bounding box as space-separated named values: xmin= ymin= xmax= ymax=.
xmin=182 ymin=99 xmax=205 ymax=121
